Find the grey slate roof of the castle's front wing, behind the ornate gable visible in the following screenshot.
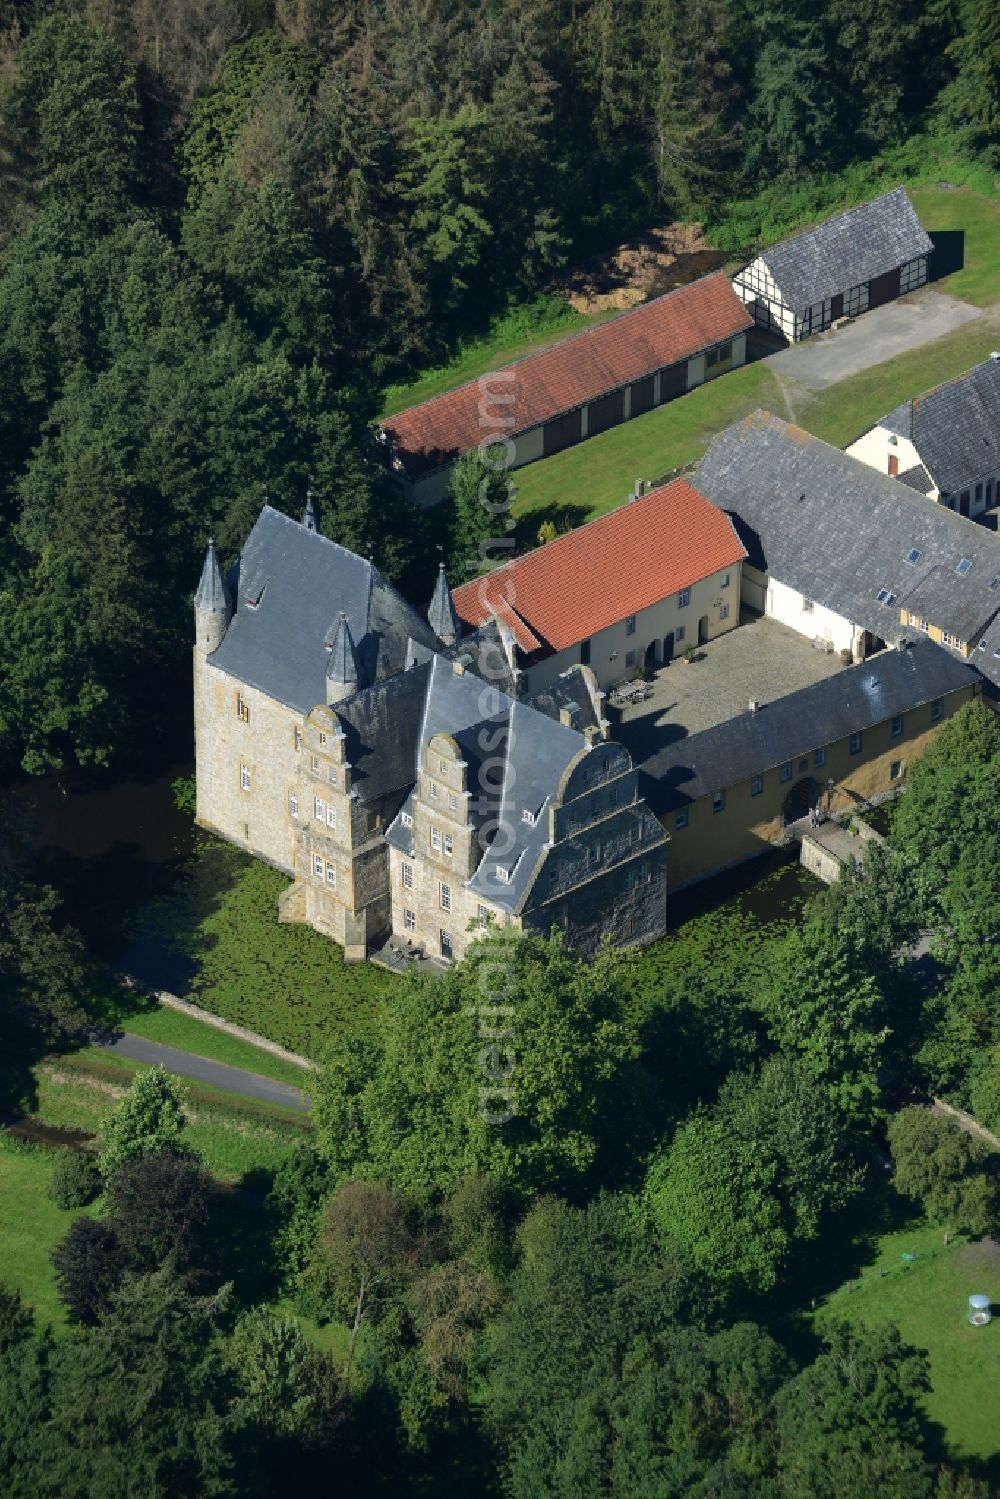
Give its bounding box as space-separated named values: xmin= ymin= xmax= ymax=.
xmin=385 ymin=657 xmax=585 ymax=911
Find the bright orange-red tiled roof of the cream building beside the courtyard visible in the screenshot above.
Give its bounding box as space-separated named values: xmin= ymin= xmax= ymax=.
xmin=454 ymin=478 xmax=747 ymax=655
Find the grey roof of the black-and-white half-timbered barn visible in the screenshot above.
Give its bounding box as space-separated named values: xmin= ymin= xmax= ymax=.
xmin=760 ymin=187 xmax=934 ymax=312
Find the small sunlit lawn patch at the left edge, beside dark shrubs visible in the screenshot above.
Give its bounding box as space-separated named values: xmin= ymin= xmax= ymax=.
xmin=0 ymin=1130 xmax=88 ymax=1327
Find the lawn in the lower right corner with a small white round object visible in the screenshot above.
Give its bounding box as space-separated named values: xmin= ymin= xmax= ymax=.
xmin=813 ymin=1226 xmax=1000 ymax=1483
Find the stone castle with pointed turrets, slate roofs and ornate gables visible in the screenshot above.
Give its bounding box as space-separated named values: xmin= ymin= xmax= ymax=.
xmin=195 ymin=505 xmax=667 ymax=961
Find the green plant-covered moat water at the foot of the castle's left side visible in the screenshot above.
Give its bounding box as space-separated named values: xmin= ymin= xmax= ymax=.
xmin=131 ymin=836 xmax=405 ymax=1061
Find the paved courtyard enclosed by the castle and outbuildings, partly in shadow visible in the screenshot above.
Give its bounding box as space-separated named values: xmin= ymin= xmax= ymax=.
xmin=606 ymin=609 xmax=844 ymax=764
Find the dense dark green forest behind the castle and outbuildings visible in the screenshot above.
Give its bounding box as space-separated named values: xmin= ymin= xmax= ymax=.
xmin=0 ymin=0 xmax=1000 ymax=772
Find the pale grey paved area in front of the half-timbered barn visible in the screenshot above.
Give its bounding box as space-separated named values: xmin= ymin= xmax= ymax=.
xmin=765 ymin=286 xmax=984 ymax=390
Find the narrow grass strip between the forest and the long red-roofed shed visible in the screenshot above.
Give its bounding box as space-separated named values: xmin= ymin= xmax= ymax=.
xmin=382 ymin=295 xmax=612 ymax=417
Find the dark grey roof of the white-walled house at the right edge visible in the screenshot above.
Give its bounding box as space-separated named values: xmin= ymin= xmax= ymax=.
xmin=876 ymin=360 xmax=1000 ymax=495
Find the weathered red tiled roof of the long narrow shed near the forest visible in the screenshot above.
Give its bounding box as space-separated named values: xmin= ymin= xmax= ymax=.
xmin=382 ymin=271 xmax=753 ymax=474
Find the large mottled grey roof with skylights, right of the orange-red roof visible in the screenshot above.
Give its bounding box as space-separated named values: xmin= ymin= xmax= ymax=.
xmin=694 ymin=411 xmax=1000 ymax=642
